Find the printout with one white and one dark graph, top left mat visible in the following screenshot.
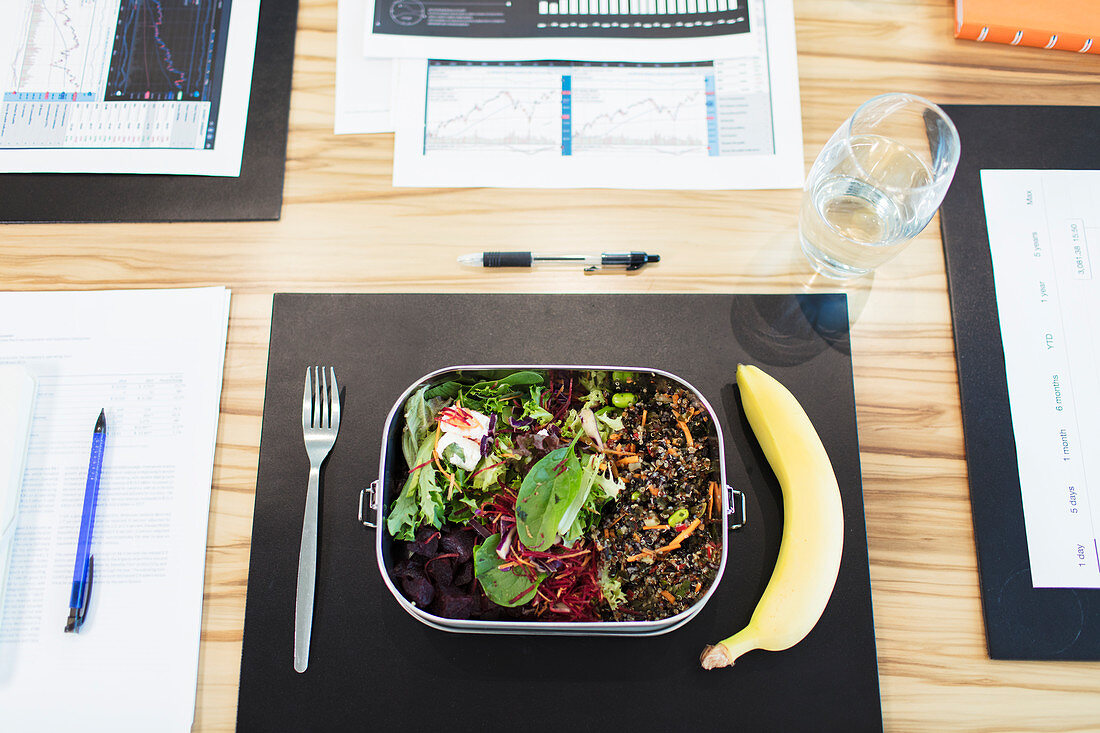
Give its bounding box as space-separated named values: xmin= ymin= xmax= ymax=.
xmin=0 ymin=0 xmax=260 ymax=176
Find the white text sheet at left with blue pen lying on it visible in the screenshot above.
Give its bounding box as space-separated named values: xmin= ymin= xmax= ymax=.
xmin=0 ymin=287 xmax=229 ymax=733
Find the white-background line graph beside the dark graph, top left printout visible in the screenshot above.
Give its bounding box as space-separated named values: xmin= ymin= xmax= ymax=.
xmin=0 ymin=0 xmax=118 ymax=95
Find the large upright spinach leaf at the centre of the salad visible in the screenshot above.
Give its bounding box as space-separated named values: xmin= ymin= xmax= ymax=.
xmin=516 ymin=444 xmax=591 ymax=550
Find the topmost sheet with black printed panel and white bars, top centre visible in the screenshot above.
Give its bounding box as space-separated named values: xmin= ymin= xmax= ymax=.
xmin=364 ymin=0 xmax=758 ymax=62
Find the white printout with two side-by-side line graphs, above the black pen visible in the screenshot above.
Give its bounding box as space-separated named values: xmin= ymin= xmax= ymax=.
xmin=394 ymin=0 xmax=803 ymax=189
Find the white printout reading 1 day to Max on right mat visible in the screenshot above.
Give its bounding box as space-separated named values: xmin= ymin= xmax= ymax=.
xmin=981 ymin=171 xmax=1100 ymax=588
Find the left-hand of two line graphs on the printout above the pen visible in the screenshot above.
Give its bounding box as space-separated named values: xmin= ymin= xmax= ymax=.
xmin=425 ymin=66 xmax=562 ymax=155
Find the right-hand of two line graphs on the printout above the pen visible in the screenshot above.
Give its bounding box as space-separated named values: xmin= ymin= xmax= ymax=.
xmin=572 ymin=67 xmax=707 ymax=155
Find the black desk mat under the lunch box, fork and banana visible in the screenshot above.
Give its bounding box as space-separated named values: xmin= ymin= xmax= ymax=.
xmin=238 ymin=294 xmax=882 ymax=732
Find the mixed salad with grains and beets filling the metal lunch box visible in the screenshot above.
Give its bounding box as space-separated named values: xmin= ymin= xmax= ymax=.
xmin=386 ymin=371 xmax=721 ymax=621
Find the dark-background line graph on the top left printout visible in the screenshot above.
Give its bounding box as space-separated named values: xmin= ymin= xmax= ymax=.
xmin=106 ymin=0 xmax=229 ymax=100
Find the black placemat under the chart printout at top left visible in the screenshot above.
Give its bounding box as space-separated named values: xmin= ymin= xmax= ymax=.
xmin=0 ymin=0 xmax=298 ymax=222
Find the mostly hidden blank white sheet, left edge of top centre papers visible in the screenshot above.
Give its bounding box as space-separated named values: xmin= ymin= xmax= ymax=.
xmin=333 ymin=0 xmax=396 ymax=135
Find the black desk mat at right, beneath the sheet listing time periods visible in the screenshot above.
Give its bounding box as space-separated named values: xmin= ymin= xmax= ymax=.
xmin=939 ymin=105 xmax=1100 ymax=659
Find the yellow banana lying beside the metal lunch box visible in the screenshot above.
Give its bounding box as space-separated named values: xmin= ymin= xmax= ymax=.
xmin=700 ymin=364 xmax=844 ymax=669
